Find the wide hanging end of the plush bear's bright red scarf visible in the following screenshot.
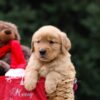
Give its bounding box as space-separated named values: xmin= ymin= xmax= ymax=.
xmin=10 ymin=40 xmax=26 ymax=68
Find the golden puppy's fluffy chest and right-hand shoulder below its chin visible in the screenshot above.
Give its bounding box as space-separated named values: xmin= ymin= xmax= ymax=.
xmin=39 ymin=54 xmax=73 ymax=77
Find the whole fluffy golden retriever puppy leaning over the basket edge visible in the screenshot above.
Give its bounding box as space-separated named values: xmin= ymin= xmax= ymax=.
xmin=24 ymin=25 xmax=76 ymax=100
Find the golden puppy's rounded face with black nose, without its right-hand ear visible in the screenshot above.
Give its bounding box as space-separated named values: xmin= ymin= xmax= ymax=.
xmin=32 ymin=26 xmax=68 ymax=62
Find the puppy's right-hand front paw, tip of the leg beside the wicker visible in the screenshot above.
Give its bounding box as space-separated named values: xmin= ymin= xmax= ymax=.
xmin=45 ymin=82 xmax=56 ymax=94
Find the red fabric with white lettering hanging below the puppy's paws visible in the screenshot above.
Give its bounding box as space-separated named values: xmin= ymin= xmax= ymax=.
xmin=0 ymin=77 xmax=47 ymax=100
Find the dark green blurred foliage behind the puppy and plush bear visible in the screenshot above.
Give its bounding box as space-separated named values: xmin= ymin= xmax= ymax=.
xmin=0 ymin=0 xmax=100 ymax=100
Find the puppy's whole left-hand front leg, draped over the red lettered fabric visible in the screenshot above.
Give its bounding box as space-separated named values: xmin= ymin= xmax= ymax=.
xmin=24 ymin=55 xmax=39 ymax=91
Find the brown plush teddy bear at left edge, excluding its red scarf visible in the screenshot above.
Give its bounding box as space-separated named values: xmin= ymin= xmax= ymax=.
xmin=0 ymin=20 xmax=31 ymax=75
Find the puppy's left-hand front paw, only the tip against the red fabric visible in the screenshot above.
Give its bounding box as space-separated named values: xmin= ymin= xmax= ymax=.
xmin=24 ymin=80 xmax=37 ymax=91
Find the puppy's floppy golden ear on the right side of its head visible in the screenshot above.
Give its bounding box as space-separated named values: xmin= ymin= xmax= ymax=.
xmin=60 ymin=32 xmax=71 ymax=54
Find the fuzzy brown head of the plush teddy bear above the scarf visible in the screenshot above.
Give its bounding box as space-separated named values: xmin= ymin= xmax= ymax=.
xmin=0 ymin=21 xmax=20 ymax=46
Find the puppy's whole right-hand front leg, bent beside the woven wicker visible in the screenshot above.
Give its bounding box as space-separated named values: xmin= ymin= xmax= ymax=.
xmin=45 ymin=71 xmax=61 ymax=94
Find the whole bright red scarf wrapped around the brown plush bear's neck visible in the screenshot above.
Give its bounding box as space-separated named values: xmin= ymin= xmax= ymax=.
xmin=0 ymin=40 xmax=26 ymax=68
